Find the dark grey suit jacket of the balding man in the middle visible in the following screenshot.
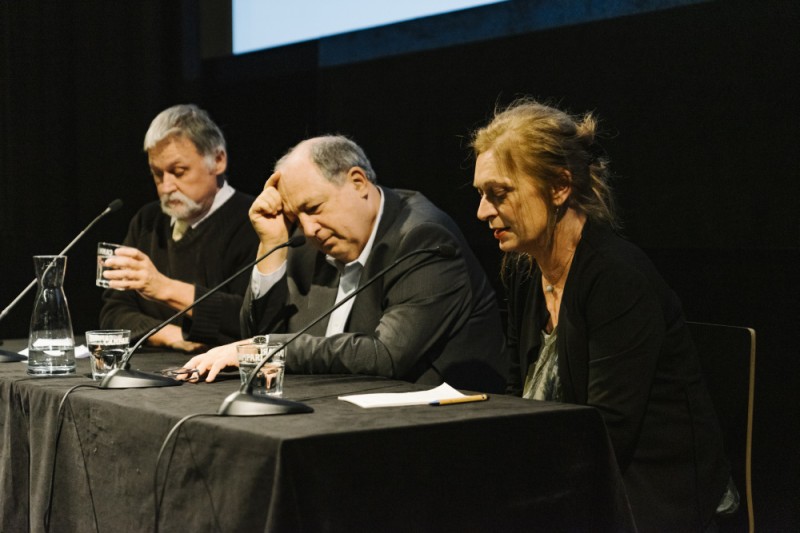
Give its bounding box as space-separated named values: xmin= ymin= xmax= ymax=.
xmin=242 ymin=188 xmax=508 ymax=392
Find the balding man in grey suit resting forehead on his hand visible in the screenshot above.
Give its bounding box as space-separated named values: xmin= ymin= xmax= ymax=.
xmin=185 ymin=136 xmax=508 ymax=392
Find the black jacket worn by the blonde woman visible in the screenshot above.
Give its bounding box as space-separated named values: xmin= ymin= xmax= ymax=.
xmin=507 ymin=222 xmax=728 ymax=531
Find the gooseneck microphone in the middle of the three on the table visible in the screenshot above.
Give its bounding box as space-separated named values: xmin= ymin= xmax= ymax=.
xmin=100 ymin=235 xmax=306 ymax=389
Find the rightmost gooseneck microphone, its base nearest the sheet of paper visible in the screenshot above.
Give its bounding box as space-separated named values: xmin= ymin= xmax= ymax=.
xmin=217 ymin=244 xmax=456 ymax=416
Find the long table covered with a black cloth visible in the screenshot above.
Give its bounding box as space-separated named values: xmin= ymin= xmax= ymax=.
xmin=0 ymin=342 xmax=633 ymax=532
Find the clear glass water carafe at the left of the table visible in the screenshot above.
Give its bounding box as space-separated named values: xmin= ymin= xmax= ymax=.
xmin=28 ymin=255 xmax=75 ymax=376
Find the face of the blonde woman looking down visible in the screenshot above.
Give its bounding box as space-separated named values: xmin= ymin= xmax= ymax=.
xmin=473 ymin=150 xmax=549 ymax=256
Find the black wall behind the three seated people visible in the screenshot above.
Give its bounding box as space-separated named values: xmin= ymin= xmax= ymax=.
xmin=0 ymin=0 xmax=800 ymax=531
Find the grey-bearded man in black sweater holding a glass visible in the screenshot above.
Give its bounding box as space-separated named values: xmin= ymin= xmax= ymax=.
xmin=100 ymin=105 xmax=258 ymax=352
